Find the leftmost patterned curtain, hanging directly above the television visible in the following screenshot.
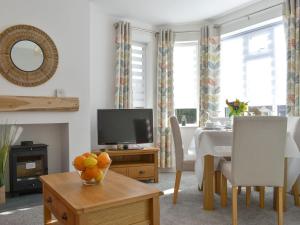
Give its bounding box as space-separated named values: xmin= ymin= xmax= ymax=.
xmin=115 ymin=22 xmax=132 ymax=109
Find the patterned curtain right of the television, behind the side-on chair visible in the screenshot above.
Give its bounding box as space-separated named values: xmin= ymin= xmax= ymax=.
xmin=156 ymin=30 xmax=174 ymax=168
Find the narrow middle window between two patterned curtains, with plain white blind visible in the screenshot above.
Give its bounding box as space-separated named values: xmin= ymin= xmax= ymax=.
xmin=173 ymin=41 xmax=199 ymax=124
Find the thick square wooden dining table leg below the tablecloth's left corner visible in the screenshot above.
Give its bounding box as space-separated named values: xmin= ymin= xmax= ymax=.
xmin=203 ymin=155 xmax=214 ymax=210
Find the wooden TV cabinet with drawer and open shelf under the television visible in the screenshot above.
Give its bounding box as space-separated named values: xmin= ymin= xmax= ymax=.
xmin=93 ymin=148 xmax=159 ymax=183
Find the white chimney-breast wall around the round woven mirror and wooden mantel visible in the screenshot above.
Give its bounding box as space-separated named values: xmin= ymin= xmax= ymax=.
xmin=0 ymin=0 xmax=90 ymax=169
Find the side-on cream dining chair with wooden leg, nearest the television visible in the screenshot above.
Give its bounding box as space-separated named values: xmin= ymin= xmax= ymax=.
xmin=170 ymin=116 xmax=195 ymax=204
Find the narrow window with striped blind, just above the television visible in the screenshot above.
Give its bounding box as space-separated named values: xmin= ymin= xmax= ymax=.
xmin=131 ymin=43 xmax=146 ymax=108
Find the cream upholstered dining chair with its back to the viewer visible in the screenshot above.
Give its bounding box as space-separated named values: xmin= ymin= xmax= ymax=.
xmin=221 ymin=116 xmax=287 ymax=225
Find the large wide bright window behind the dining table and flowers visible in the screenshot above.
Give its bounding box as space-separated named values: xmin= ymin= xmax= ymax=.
xmin=220 ymin=20 xmax=287 ymax=115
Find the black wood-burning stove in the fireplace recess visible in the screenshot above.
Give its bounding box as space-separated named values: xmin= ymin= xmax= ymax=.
xmin=9 ymin=144 xmax=48 ymax=194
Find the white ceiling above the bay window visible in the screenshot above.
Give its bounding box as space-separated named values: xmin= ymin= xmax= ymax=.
xmin=94 ymin=0 xmax=257 ymax=25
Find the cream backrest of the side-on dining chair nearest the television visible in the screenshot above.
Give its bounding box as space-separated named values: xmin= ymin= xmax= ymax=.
xmin=170 ymin=116 xmax=184 ymax=171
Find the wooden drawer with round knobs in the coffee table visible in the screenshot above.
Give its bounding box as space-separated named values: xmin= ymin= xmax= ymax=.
xmin=44 ymin=189 xmax=75 ymax=225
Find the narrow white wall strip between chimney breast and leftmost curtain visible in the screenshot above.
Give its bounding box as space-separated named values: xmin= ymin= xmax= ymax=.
xmin=90 ymin=2 xmax=115 ymax=148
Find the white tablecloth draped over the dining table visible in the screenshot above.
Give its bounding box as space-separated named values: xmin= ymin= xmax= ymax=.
xmin=189 ymin=128 xmax=300 ymax=191
